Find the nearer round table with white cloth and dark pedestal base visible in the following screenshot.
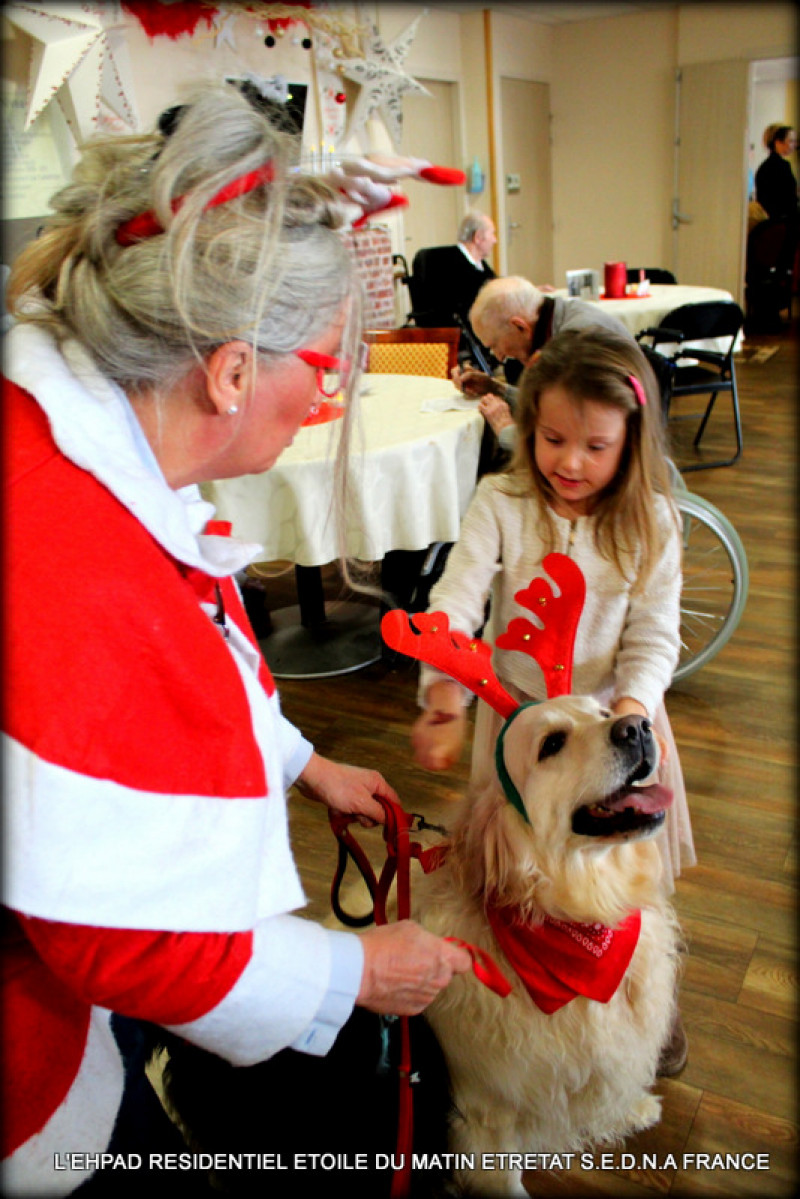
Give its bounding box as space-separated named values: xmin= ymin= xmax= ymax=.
xmin=203 ymin=374 xmax=483 ymax=679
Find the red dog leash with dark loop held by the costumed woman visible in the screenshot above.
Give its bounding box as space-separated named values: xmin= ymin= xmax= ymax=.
xmin=329 ymin=795 xmax=511 ymax=1199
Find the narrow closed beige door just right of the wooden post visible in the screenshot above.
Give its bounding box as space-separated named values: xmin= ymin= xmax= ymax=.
xmin=498 ymin=78 xmax=553 ymax=284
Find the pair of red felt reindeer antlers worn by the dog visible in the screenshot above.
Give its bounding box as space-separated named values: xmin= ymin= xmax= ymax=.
xmin=380 ymin=554 xmax=587 ymax=700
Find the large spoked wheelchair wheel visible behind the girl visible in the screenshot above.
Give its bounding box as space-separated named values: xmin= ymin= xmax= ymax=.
xmin=673 ymin=490 xmax=748 ymax=682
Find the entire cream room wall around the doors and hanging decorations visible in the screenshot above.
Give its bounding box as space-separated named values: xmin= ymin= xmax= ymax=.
xmin=4 ymin=2 xmax=796 ymax=296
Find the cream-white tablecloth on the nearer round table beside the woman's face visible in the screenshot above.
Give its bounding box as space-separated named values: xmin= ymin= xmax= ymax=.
xmin=203 ymin=374 xmax=483 ymax=566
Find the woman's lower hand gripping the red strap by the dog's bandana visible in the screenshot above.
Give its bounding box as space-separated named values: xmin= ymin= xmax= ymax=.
xmin=356 ymin=920 xmax=473 ymax=1016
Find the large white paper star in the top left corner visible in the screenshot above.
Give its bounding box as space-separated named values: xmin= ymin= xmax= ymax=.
xmin=4 ymin=4 xmax=138 ymax=140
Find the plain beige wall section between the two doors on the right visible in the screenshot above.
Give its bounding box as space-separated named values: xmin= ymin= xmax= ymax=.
xmin=552 ymin=10 xmax=676 ymax=284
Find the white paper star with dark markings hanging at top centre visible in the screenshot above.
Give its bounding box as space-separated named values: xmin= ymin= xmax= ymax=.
xmin=337 ymin=17 xmax=431 ymax=150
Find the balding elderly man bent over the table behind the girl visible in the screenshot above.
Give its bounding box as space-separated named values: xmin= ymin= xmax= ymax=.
xmin=452 ymin=275 xmax=631 ymax=450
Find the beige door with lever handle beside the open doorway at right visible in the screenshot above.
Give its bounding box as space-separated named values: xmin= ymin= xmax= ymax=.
xmin=675 ymin=59 xmax=748 ymax=303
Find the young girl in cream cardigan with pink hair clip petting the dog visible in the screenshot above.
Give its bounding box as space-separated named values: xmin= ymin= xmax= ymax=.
xmin=413 ymin=329 xmax=696 ymax=891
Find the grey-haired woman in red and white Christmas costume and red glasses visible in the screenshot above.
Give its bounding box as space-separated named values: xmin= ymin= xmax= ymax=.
xmin=2 ymin=84 xmax=470 ymax=1195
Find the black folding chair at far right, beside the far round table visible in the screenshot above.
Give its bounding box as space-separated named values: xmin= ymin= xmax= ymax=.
xmin=637 ymin=300 xmax=745 ymax=472
